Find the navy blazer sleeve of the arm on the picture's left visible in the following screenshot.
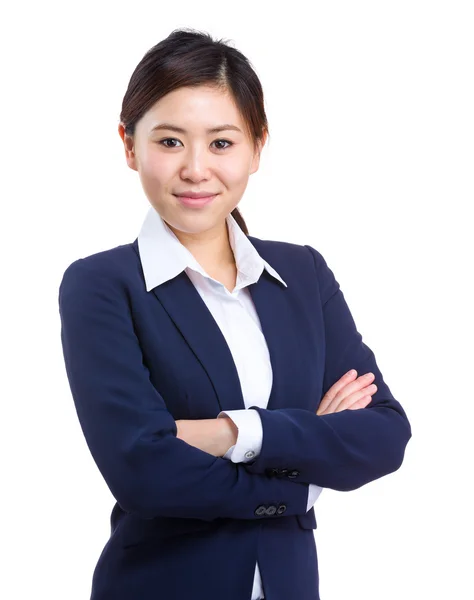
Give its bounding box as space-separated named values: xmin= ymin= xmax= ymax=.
xmin=59 ymin=258 xmax=308 ymax=521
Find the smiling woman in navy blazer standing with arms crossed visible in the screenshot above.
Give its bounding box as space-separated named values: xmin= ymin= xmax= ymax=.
xmin=59 ymin=30 xmax=411 ymax=600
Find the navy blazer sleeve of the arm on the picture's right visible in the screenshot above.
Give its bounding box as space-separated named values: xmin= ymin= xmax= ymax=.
xmin=245 ymin=246 xmax=411 ymax=491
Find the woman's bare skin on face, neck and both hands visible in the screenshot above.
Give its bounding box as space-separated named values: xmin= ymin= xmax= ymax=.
xmin=118 ymin=86 xmax=375 ymax=457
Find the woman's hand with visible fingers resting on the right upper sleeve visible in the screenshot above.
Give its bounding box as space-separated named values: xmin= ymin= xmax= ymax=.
xmin=316 ymin=371 xmax=377 ymax=415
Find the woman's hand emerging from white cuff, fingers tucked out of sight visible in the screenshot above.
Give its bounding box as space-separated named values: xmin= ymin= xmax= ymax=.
xmin=176 ymin=419 xmax=238 ymax=457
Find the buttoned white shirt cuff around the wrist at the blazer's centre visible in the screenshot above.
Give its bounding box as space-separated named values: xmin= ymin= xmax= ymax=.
xmin=217 ymin=408 xmax=263 ymax=463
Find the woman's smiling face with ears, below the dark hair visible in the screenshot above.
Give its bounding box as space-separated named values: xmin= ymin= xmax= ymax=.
xmin=119 ymin=86 xmax=265 ymax=238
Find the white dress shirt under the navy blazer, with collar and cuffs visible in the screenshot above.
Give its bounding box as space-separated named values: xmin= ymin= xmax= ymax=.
xmin=138 ymin=206 xmax=322 ymax=600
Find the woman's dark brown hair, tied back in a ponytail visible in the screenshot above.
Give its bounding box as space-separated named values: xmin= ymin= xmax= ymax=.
xmin=120 ymin=28 xmax=269 ymax=235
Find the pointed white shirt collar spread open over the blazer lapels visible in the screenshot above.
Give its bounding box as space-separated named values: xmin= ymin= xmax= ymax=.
xmin=138 ymin=206 xmax=288 ymax=292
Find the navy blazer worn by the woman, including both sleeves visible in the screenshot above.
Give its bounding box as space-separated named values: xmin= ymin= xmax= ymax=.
xmin=59 ymin=236 xmax=411 ymax=600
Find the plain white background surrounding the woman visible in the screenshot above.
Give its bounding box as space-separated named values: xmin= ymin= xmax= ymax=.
xmin=0 ymin=0 xmax=474 ymax=600
